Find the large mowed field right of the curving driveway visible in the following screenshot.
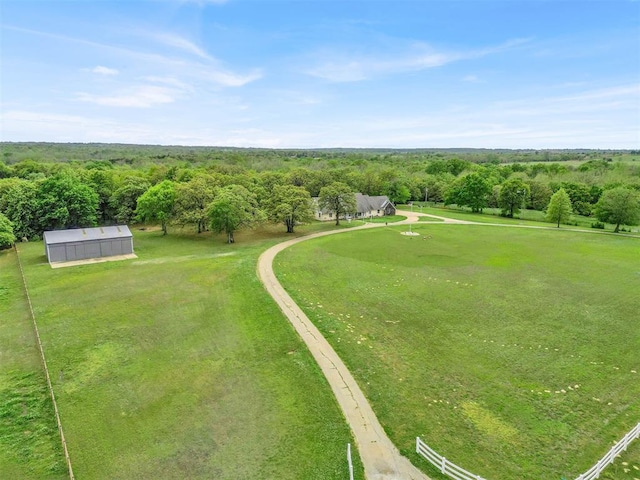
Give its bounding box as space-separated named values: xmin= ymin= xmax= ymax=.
xmin=276 ymin=224 xmax=640 ymax=480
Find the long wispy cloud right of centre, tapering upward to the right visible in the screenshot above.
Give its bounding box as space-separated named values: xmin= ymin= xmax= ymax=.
xmin=305 ymin=39 xmax=529 ymax=82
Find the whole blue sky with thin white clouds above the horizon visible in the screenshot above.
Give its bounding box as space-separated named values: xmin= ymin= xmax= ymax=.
xmin=0 ymin=0 xmax=640 ymax=149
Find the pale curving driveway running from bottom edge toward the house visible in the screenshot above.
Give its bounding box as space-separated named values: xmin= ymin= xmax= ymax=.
xmin=257 ymin=212 xmax=429 ymax=480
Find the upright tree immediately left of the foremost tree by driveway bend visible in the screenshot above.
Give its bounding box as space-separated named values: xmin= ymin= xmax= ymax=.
xmin=173 ymin=175 xmax=215 ymax=233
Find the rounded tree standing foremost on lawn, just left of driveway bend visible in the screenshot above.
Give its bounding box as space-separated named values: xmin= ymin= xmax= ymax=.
xmin=207 ymin=185 xmax=265 ymax=243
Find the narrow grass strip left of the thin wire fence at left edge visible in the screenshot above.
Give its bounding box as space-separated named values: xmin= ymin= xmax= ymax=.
xmin=0 ymin=250 xmax=68 ymax=480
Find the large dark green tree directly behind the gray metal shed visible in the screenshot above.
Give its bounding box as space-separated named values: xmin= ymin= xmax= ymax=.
xmin=36 ymin=171 xmax=98 ymax=231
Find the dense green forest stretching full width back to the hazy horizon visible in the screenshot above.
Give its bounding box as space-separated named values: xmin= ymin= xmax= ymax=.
xmin=0 ymin=143 xmax=640 ymax=244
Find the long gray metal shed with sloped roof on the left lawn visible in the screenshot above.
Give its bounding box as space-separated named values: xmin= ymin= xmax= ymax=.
xmin=43 ymin=225 xmax=133 ymax=263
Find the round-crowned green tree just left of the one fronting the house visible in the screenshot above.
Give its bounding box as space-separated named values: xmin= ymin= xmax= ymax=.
xmin=264 ymin=185 xmax=313 ymax=233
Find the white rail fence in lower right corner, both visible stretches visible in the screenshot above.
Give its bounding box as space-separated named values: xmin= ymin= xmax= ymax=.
xmin=416 ymin=423 xmax=640 ymax=480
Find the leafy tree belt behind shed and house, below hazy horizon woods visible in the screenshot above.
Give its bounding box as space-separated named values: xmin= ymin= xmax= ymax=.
xmin=0 ymin=145 xmax=640 ymax=245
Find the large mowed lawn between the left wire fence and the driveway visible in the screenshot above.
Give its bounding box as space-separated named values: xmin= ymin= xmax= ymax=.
xmin=20 ymin=226 xmax=362 ymax=480
